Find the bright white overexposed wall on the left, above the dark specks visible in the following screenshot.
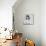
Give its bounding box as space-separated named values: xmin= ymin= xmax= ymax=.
xmin=0 ymin=0 xmax=16 ymax=29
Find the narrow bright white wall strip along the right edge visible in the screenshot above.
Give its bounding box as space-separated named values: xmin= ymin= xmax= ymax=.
xmin=41 ymin=0 xmax=46 ymax=46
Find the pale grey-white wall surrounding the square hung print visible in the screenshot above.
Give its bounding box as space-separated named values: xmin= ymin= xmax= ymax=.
xmin=14 ymin=0 xmax=41 ymax=46
